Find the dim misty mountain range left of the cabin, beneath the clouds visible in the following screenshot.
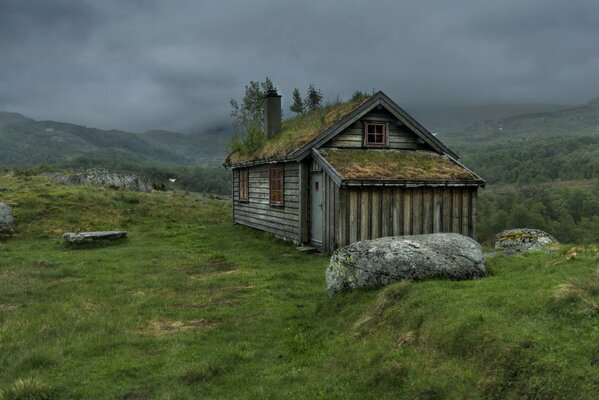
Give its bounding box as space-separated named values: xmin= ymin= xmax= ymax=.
xmin=0 ymin=112 xmax=228 ymax=165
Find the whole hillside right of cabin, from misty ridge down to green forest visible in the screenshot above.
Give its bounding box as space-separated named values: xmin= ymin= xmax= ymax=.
xmin=441 ymin=100 xmax=599 ymax=243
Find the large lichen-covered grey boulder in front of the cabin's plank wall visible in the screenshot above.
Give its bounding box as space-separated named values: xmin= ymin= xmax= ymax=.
xmin=326 ymin=233 xmax=487 ymax=295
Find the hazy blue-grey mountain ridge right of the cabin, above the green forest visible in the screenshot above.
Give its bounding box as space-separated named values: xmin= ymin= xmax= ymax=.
xmin=441 ymin=98 xmax=599 ymax=146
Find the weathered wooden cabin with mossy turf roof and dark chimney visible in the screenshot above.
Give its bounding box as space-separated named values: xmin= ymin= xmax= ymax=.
xmin=225 ymin=91 xmax=485 ymax=252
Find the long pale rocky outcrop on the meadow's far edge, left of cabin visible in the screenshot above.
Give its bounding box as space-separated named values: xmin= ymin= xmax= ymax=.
xmin=52 ymin=169 xmax=152 ymax=192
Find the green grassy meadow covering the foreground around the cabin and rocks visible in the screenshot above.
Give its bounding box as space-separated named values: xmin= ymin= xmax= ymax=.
xmin=0 ymin=175 xmax=599 ymax=400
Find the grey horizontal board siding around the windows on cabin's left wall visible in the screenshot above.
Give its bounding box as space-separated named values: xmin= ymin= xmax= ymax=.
xmin=233 ymin=163 xmax=300 ymax=242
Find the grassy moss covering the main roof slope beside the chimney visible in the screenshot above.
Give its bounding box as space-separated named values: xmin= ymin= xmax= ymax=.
xmin=227 ymin=96 xmax=371 ymax=164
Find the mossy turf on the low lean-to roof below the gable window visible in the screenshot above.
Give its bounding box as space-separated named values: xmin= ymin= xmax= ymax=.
xmin=320 ymin=149 xmax=477 ymax=181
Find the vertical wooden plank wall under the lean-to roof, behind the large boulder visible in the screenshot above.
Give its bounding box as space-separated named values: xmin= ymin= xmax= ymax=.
xmin=338 ymin=186 xmax=477 ymax=251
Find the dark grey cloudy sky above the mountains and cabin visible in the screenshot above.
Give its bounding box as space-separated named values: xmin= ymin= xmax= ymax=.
xmin=0 ymin=0 xmax=599 ymax=132
